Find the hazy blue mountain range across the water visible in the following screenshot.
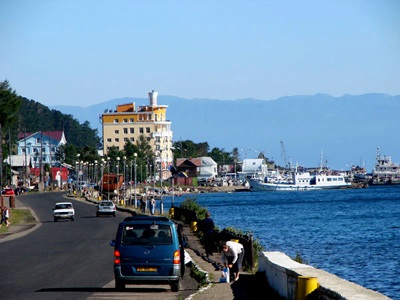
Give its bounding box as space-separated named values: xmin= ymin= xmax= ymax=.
xmin=50 ymin=94 xmax=400 ymax=172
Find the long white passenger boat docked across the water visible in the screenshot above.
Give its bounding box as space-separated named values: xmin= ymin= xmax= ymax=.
xmin=249 ymin=170 xmax=351 ymax=191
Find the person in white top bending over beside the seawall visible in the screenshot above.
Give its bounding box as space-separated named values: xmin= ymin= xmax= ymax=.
xmin=221 ymin=241 xmax=244 ymax=281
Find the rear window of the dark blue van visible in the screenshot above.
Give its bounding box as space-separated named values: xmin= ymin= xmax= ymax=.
xmin=122 ymin=224 xmax=172 ymax=245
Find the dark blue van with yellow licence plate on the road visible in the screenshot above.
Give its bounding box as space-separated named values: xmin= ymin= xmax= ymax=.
xmin=110 ymin=215 xmax=184 ymax=292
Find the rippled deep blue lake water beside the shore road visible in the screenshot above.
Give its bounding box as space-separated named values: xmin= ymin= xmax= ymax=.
xmin=164 ymin=186 xmax=400 ymax=299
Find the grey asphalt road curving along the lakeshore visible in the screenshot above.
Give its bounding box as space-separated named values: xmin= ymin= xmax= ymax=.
xmin=0 ymin=192 xmax=195 ymax=300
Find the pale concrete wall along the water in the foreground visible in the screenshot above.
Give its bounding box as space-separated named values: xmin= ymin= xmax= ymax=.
xmin=258 ymin=252 xmax=390 ymax=300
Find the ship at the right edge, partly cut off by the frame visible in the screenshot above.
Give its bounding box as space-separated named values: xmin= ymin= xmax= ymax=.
xmin=371 ymin=148 xmax=400 ymax=185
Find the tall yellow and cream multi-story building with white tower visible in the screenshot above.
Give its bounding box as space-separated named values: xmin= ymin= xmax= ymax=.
xmin=101 ymin=90 xmax=173 ymax=179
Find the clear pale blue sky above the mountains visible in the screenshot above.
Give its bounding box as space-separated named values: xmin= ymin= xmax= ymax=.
xmin=0 ymin=0 xmax=400 ymax=107
